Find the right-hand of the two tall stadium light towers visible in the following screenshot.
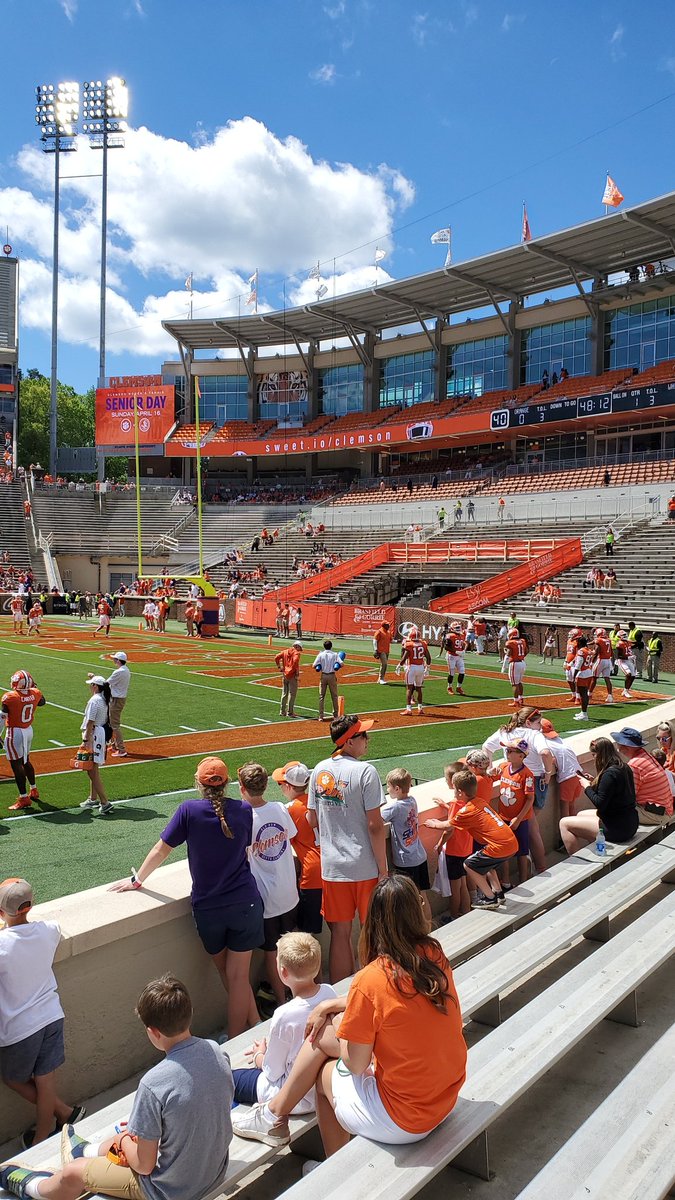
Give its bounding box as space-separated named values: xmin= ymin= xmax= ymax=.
xmin=82 ymin=76 xmax=129 ymax=479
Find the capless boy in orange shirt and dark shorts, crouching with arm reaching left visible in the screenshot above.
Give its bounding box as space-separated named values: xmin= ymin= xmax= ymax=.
xmin=425 ymin=769 xmax=518 ymax=908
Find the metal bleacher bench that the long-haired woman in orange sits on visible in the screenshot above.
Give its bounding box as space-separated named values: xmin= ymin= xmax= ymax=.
xmin=271 ymin=890 xmax=675 ymax=1200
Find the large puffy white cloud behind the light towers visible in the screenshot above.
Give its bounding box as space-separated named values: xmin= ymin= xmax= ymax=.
xmin=0 ymin=118 xmax=414 ymax=355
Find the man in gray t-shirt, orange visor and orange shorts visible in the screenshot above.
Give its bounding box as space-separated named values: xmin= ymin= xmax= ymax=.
xmin=307 ymin=715 xmax=388 ymax=983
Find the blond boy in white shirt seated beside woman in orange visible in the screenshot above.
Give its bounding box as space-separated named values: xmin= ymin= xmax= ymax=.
xmin=233 ymin=934 xmax=336 ymax=1114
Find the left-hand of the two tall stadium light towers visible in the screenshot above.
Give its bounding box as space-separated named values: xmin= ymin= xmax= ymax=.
xmin=35 ymin=83 xmax=79 ymax=475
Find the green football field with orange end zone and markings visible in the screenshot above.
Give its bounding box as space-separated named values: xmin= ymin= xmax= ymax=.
xmin=0 ymin=618 xmax=669 ymax=900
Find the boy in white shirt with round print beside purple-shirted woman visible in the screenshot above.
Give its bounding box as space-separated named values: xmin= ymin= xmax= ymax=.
xmin=238 ymin=762 xmax=299 ymax=1004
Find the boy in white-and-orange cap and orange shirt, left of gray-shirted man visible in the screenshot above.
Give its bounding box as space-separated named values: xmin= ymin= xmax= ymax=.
xmin=271 ymin=760 xmax=323 ymax=934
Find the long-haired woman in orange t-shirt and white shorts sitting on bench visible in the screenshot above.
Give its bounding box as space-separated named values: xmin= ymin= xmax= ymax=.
xmin=232 ymin=875 xmax=466 ymax=1156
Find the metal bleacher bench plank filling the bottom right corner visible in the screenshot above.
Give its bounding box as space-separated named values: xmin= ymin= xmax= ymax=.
xmin=509 ymin=1025 xmax=675 ymax=1200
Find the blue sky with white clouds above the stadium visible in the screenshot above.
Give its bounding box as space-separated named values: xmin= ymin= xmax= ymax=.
xmin=0 ymin=0 xmax=675 ymax=389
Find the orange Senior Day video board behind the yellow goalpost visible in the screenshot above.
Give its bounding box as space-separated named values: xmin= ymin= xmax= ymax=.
xmin=96 ymin=384 xmax=175 ymax=446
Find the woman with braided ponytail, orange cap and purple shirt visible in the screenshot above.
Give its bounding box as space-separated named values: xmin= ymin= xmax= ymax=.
xmin=110 ymin=758 xmax=264 ymax=1038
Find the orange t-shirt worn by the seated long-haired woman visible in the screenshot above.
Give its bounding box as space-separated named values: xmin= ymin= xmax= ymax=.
xmin=336 ymin=943 xmax=466 ymax=1133
